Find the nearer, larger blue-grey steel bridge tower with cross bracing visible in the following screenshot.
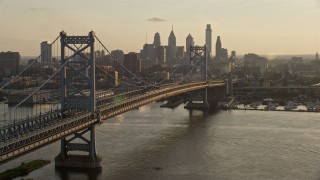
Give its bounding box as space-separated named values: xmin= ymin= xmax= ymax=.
xmin=55 ymin=31 xmax=101 ymax=168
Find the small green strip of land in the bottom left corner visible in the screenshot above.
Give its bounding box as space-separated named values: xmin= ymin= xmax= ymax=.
xmin=0 ymin=160 xmax=51 ymax=180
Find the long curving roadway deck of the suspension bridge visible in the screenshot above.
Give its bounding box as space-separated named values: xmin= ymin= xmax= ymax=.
xmin=0 ymin=81 xmax=224 ymax=164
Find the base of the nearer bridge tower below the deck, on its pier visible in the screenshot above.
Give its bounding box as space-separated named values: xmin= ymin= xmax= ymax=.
xmin=54 ymin=126 xmax=101 ymax=168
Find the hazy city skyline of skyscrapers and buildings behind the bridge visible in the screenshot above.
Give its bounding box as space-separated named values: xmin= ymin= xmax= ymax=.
xmin=0 ymin=24 xmax=320 ymax=93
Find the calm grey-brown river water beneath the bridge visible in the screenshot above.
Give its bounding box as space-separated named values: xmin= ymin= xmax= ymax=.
xmin=0 ymin=103 xmax=320 ymax=180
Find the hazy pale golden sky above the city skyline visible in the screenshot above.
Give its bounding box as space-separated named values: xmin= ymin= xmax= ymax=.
xmin=0 ymin=0 xmax=320 ymax=56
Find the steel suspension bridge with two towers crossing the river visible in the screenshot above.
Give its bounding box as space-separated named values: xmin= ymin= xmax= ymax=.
xmin=0 ymin=32 xmax=225 ymax=168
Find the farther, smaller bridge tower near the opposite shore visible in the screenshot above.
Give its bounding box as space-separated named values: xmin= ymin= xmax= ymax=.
xmin=185 ymin=45 xmax=209 ymax=110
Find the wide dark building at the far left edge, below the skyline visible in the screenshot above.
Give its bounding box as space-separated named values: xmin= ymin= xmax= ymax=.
xmin=0 ymin=51 xmax=20 ymax=77
